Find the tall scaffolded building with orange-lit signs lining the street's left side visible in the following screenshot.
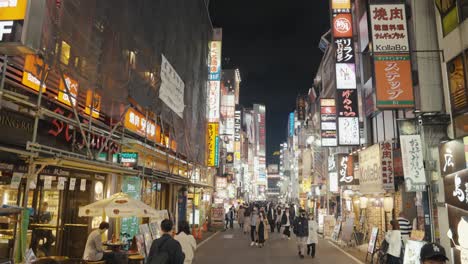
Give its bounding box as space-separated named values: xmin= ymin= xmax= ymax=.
xmin=0 ymin=0 xmax=213 ymax=258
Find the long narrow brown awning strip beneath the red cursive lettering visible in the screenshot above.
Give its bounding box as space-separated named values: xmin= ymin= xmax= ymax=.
xmin=35 ymin=157 xmax=139 ymax=175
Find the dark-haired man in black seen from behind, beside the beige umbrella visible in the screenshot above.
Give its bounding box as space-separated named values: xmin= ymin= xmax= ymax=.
xmin=148 ymin=219 xmax=185 ymax=264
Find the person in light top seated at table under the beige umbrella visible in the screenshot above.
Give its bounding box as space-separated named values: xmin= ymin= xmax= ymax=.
xmin=83 ymin=222 xmax=114 ymax=263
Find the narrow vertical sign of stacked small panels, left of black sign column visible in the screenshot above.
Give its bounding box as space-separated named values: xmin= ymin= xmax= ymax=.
xmin=320 ymin=98 xmax=338 ymax=147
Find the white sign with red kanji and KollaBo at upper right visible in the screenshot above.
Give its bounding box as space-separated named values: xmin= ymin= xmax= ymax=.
xmin=370 ymin=4 xmax=410 ymax=53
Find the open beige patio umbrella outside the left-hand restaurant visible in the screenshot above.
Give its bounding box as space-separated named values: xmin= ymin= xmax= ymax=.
xmin=78 ymin=192 xmax=163 ymax=218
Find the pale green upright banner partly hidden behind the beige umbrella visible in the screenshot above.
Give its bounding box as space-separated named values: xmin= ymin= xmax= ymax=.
xmin=120 ymin=176 xmax=141 ymax=239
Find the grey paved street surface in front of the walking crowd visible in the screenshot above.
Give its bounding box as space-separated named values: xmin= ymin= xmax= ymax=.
xmin=194 ymin=229 xmax=362 ymax=264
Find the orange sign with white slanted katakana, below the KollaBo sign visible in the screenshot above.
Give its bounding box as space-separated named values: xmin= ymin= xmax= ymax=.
xmin=374 ymin=54 xmax=414 ymax=109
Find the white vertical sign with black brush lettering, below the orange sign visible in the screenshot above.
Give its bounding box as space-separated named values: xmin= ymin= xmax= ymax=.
xmin=400 ymin=135 xmax=426 ymax=192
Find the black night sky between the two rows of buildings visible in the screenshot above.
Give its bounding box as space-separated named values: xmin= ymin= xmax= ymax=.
xmin=210 ymin=0 xmax=330 ymax=162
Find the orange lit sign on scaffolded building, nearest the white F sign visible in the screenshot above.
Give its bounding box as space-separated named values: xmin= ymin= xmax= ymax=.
xmin=21 ymin=54 xmax=48 ymax=92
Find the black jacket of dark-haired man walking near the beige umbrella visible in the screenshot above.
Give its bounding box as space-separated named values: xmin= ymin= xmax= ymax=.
xmin=146 ymin=234 xmax=185 ymax=264
